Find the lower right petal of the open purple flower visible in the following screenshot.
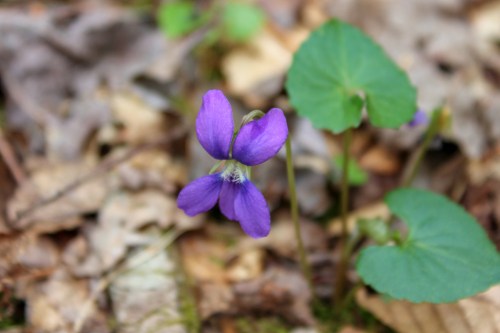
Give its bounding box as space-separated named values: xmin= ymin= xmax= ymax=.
xmin=234 ymin=180 xmax=271 ymax=238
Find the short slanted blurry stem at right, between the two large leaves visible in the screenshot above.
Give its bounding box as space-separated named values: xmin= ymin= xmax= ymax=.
xmin=401 ymin=108 xmax=443 ymax=187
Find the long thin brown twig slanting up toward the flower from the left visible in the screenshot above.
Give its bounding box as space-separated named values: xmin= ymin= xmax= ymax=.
xmin=14 ymin=126 xmax=187 ymax=223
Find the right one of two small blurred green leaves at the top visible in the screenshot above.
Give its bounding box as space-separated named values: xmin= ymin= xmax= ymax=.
xmin=222 ymin=2 xmax=265 ymax=42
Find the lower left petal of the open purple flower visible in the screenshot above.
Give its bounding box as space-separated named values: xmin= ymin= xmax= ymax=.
xmin=177 ymin=173 xmax=223 ymax=216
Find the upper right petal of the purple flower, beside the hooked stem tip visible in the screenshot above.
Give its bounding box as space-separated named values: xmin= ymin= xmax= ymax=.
xmin=233 ymin=108 xmax=288 ymax=165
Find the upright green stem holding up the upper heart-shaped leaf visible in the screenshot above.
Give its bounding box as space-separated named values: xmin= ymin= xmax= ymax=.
xmin=333 ymin=128 xmax=352 ymax=309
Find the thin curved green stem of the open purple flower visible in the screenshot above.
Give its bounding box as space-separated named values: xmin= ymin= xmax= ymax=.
xmin=286 ymin=137 xmax=315 ymax=300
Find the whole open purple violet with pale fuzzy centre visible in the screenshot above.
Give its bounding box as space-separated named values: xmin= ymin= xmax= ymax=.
xmin=177 ymin=90 xmax=288 ymax=238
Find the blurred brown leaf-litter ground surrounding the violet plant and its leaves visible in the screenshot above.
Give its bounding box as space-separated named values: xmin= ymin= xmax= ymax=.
xmin=0 ymin=0 xmax=500 ymax=333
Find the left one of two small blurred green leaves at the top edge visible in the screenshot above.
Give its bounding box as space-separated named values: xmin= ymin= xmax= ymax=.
xmin=158 ymin=0 xmax=201 ymax=38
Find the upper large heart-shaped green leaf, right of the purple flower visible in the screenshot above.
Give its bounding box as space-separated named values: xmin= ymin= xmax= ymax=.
xmin=286 ymin=20 xmax=417 ymax=133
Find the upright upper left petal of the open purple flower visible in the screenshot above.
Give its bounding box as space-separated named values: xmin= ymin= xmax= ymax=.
xmin=196 ymin=90 xmax=234 ymax=160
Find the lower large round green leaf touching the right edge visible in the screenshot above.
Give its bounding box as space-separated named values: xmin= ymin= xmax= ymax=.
xmin=356 ymin=189 xmax=500 ymax=303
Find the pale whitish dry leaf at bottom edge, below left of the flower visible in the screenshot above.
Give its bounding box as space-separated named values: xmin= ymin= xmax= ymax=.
xmin=110 ymin=243 xmax=186 ymax=333
